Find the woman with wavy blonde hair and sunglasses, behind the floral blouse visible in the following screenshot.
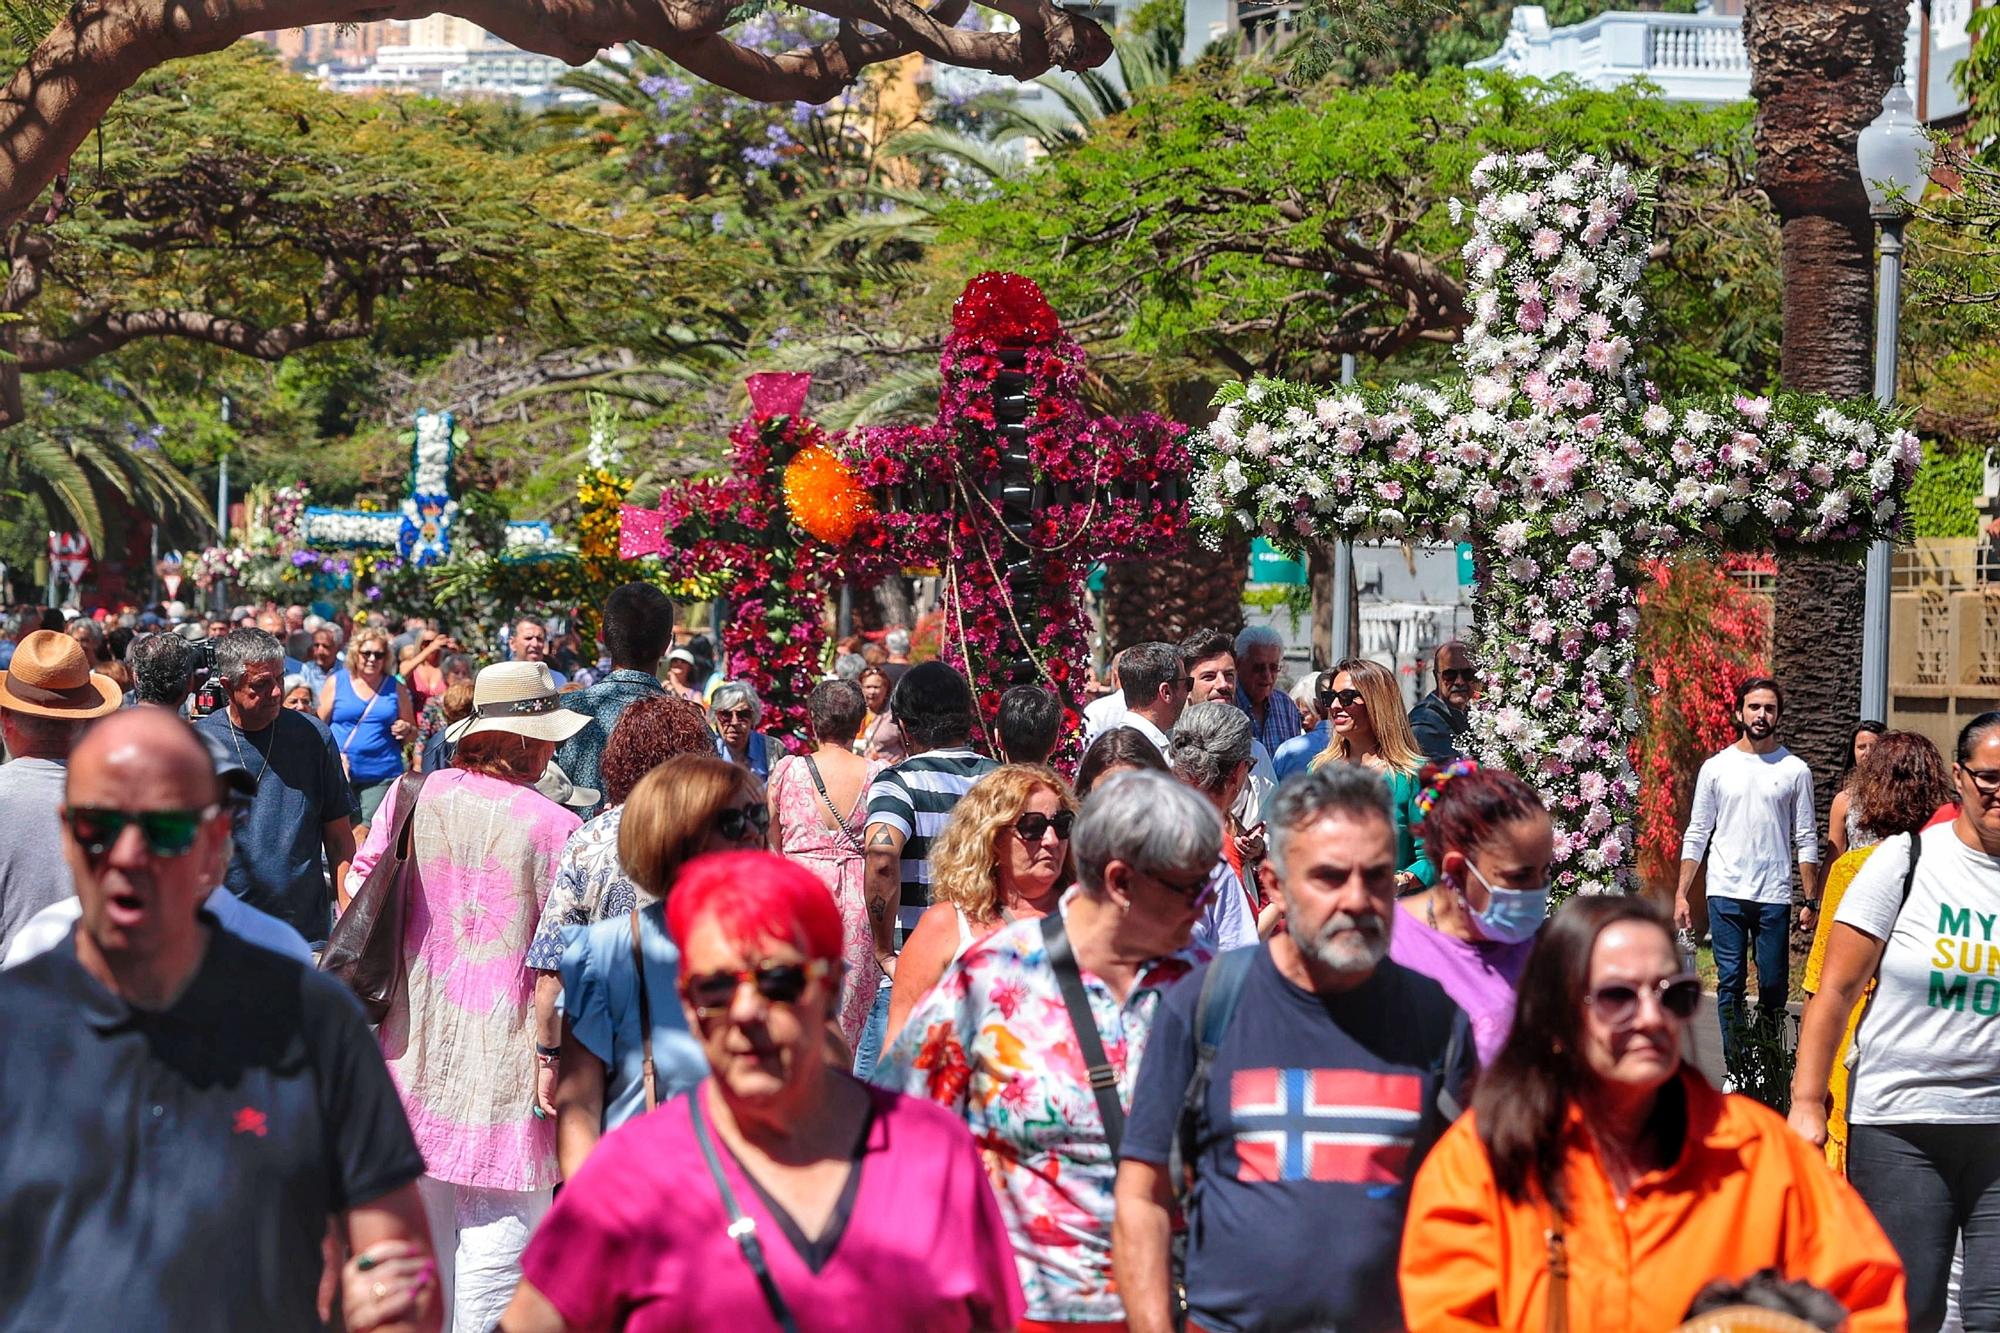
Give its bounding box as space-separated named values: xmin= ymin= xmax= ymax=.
xmin=882 ymin=765 xmax=1076 ymax=1047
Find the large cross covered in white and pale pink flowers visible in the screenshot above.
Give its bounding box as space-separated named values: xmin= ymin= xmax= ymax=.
xmin=1194 ymin=152 xmax=1920 ymax=893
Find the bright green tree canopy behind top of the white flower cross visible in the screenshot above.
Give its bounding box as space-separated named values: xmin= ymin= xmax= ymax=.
xmin=940 ymin=68 xmax=1778 ymax=390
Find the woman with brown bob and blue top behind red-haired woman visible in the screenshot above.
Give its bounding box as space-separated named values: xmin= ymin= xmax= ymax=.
xmin=554 ymin=752 xmax=770 ymax=1179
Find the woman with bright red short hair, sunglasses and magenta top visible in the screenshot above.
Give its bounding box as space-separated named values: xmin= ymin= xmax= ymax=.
xmin=500 ymin=853 xmax=1022 ymax=1333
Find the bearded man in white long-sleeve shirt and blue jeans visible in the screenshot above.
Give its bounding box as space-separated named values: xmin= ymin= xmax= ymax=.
xmin=1674 ymin=677 xmax=1820 ymax=1077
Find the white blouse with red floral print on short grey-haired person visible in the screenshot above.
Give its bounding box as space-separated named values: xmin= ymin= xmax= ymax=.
xmin=874 ymin=904 xmax=1208 ymax=1323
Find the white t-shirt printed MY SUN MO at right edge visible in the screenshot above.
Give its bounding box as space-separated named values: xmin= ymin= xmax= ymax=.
xmin=1834 ymin=825 xmax=2000 ymax=1125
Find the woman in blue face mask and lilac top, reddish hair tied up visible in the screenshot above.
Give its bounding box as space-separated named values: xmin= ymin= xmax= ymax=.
xmin=1388 ymin=759 xmax=1554 ymax=1065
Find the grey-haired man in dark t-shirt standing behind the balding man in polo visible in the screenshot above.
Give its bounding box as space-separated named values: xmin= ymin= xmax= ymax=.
xmin=196 ymin=630 xmax=354 ymax=947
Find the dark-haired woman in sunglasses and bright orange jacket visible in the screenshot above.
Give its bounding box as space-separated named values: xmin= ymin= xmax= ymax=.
xmin=1400 ymin=897 xmax=1904 ymax=1333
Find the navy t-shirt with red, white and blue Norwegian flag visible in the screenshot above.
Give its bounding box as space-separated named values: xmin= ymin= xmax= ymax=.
xmin=1122 ymin=945 xmax=1478 ymax=1333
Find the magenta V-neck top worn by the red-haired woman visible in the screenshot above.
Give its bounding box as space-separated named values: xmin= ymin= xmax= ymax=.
xmin=520 ymin=1075 xmax=1022 ymax=1333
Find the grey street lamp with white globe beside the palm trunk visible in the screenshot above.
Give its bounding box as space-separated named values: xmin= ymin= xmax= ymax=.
xmin=1854 ymin=72 xmax=1930 ymax=723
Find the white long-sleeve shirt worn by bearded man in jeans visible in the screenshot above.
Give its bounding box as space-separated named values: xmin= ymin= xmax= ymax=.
xmin=1680 ymin=745 xmax=1820 ymax=903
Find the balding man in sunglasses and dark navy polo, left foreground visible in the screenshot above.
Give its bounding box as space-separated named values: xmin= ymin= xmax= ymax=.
xmin=0 ymin=707 xmax=440 ymax=1333
